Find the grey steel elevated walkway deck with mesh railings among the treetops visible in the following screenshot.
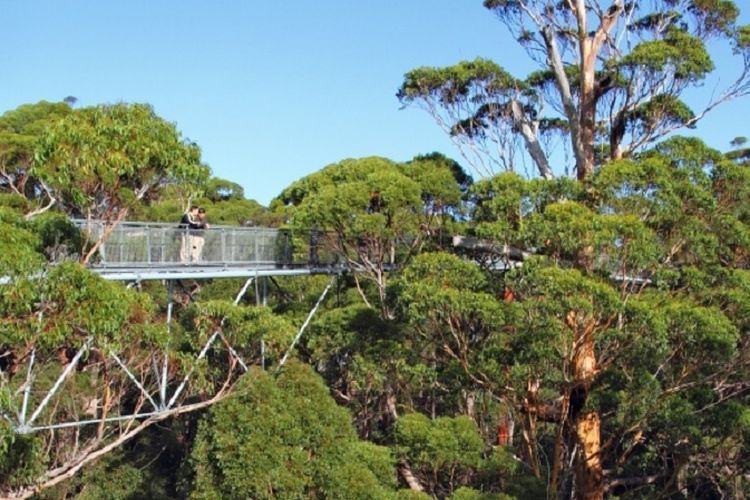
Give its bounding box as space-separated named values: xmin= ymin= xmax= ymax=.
xmin=73 ymin=220 xmax=338 ymax=281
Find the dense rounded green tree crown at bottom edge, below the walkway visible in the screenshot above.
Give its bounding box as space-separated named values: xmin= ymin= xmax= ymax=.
xmin=187 ymin=362 xmax=396 ymax=499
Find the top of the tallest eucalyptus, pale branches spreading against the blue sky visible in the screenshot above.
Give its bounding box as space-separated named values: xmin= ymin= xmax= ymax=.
xmin=398 ymin=0 xmax=750 ymax=179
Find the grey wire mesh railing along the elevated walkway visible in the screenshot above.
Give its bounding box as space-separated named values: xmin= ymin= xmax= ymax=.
xmin=74 ymin=220 xmax=294 ymax=267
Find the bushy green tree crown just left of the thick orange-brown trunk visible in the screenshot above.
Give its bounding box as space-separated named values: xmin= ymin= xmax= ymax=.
xmin=394 ymin=252 xmax=506 ymax=420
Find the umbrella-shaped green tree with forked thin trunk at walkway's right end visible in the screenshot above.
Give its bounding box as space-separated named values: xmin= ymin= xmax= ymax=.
xmin=271 ymin=157 xmax=461 ymax=317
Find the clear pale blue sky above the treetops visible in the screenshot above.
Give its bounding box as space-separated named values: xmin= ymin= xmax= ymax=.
xmin=0 ymin=0 xmax=750 ymax=204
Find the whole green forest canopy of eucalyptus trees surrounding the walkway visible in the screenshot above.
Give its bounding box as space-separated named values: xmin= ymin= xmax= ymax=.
xmin=0 ymin=0 xmax=750 ymax=500
